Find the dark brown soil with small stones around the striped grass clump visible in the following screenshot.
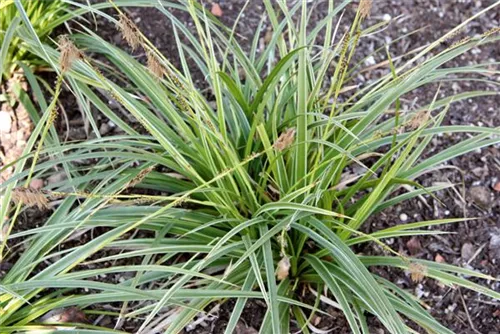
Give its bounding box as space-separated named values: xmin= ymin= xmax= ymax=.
xmin=1 ymin=0 xmax=500 ymax=334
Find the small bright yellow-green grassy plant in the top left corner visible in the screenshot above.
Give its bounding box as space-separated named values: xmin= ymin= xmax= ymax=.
xmin=0 ymin=0 xmax=66 ymax=78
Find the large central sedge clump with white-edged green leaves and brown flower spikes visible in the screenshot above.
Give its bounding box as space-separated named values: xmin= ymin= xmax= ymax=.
xmin=0 ymin=0 xmax=500 ymax=333
